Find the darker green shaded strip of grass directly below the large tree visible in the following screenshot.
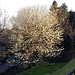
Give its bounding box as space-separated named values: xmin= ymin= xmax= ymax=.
xmin=19 ymin=63 xmax=66 ymax=75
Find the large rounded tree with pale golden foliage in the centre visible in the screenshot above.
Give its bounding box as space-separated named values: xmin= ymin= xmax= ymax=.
xmin=12 ymin=2 xmax=67 ymax=63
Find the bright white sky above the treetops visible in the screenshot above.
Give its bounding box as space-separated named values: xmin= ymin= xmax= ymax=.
xmin=0 ymin=0 xmax=75 ymax=16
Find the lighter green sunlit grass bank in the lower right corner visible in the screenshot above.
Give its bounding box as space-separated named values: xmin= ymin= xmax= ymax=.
xmin=52 ymin=58 xmax=75 ymax=75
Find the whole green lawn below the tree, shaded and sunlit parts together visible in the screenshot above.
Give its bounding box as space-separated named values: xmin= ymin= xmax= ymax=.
xmin=18 ymin=58 xmax=75 ymax=75
